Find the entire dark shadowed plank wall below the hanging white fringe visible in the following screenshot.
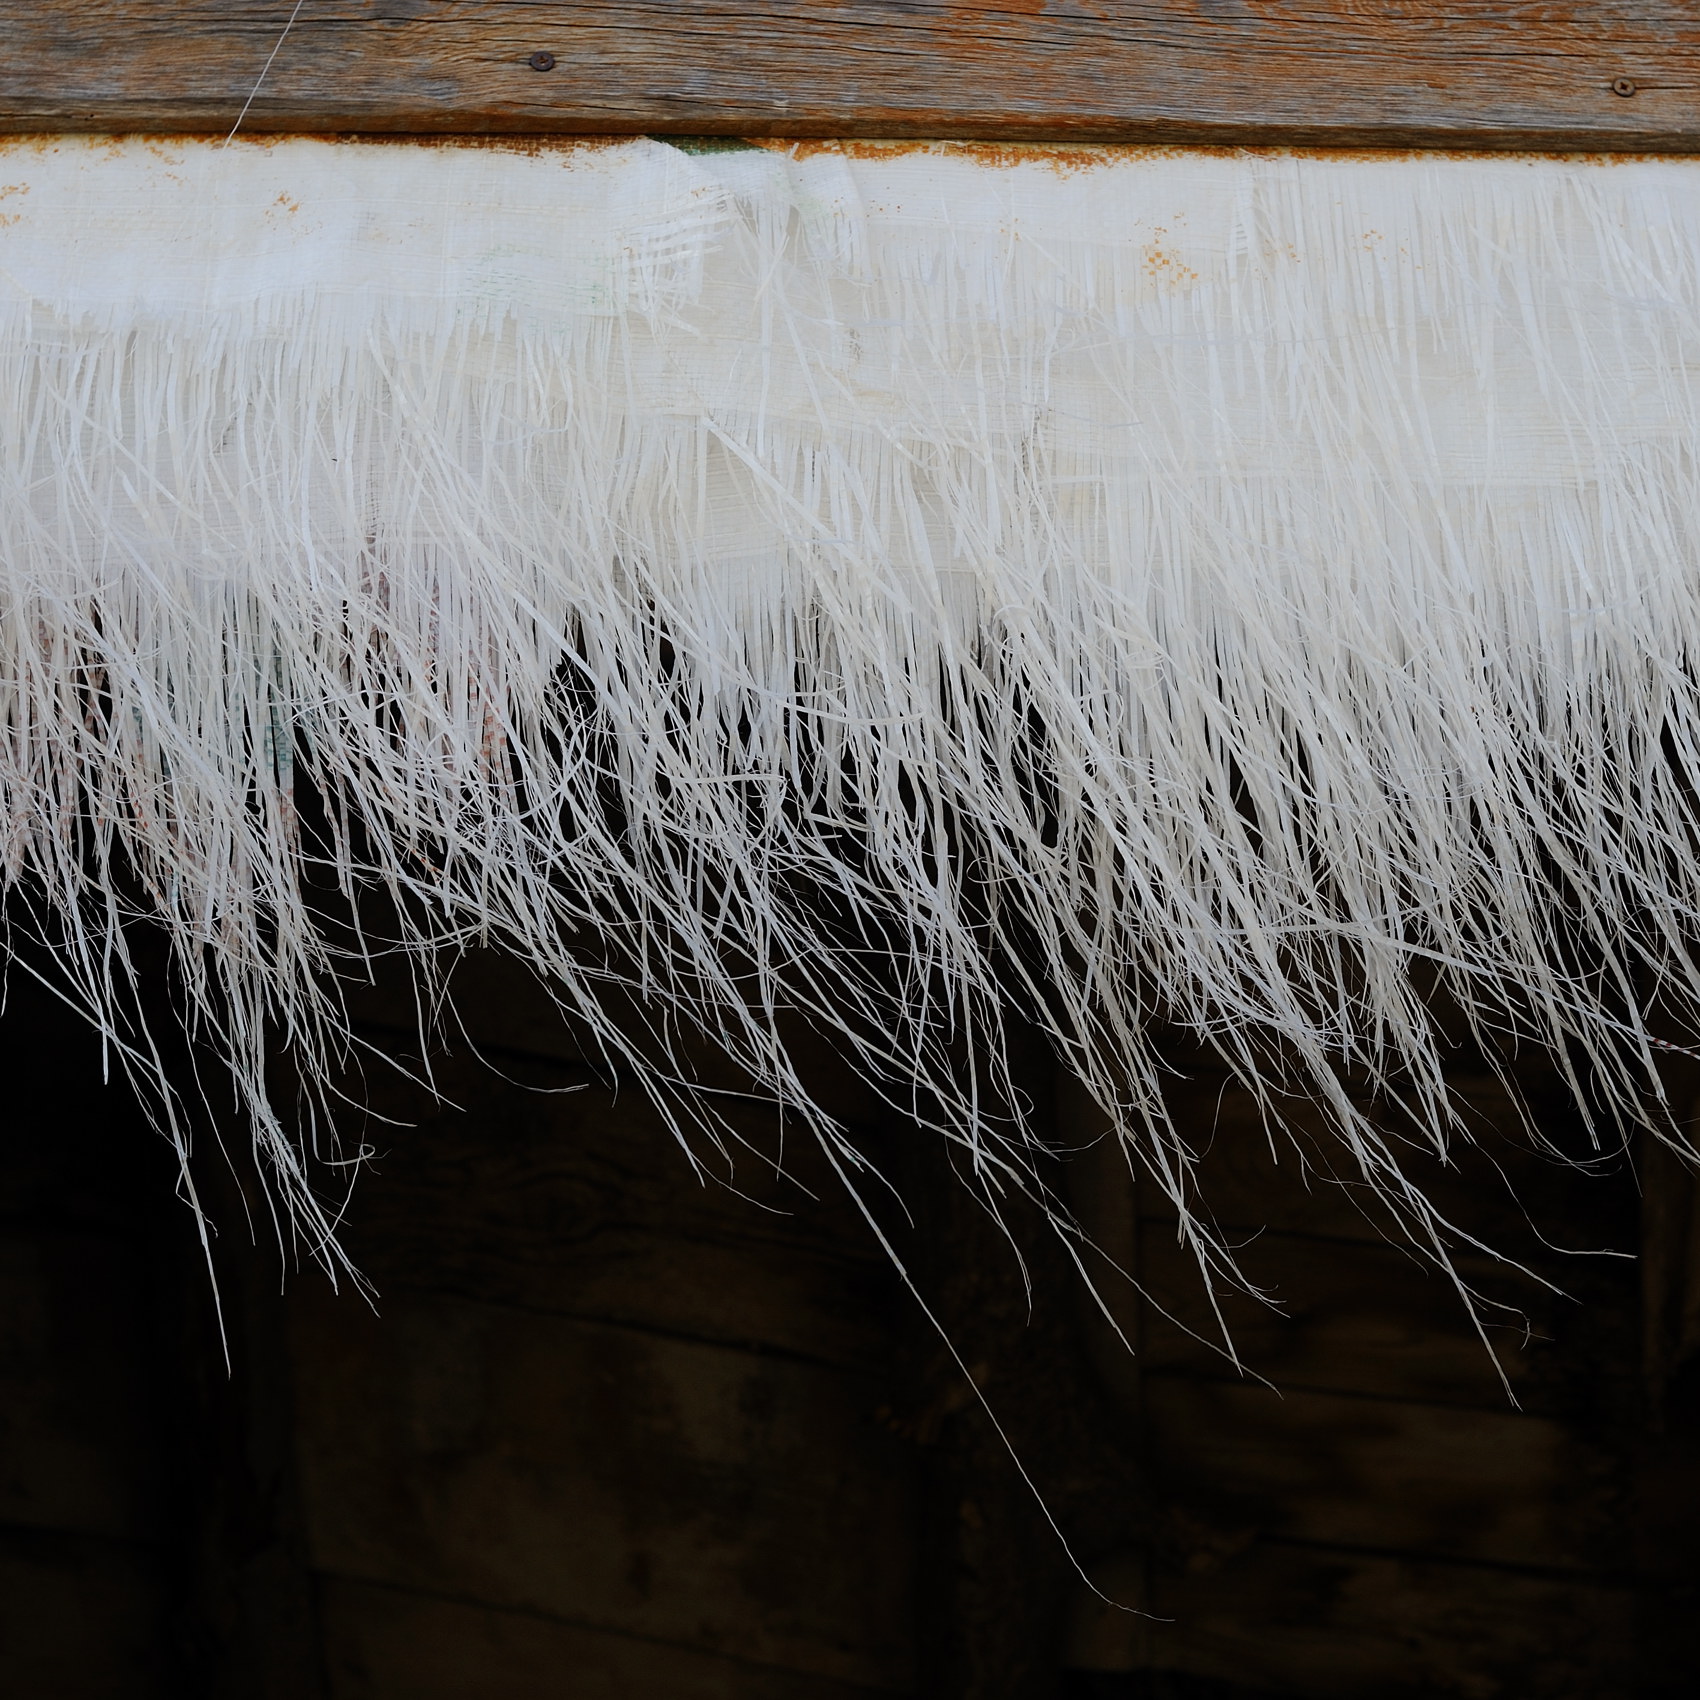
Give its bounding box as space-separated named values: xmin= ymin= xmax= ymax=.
xmin=0 ymin=964 xmax=1700 ymax=1700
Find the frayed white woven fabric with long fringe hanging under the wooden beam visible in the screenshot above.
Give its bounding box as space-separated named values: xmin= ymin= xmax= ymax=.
xmin=0 ymin=139 xmax=1700 ymax=1298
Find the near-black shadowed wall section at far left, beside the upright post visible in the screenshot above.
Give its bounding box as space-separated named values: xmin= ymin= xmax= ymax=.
xmin=0 ymin=986 xmax=198 ymax=1700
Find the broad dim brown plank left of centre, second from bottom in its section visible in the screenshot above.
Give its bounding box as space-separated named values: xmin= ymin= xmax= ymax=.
xmin=294 ymin=1295 xmax=916 ymax=1692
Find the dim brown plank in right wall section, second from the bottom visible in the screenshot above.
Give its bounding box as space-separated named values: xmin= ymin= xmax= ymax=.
xmin=1144 ymin=1374 xmax=1629 ymax=1573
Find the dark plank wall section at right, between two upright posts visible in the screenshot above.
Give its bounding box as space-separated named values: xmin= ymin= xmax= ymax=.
xmin=1074 ymin=1069 xmax=1659 ymax=1700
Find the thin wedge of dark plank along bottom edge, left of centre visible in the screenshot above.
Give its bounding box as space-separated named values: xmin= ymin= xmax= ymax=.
xmin=323 ymin=1578 xmax=904 ymax=1700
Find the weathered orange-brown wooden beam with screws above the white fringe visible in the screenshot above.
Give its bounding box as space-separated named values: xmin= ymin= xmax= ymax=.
xmin=0 ymin=0 xmax=1700 ymax=150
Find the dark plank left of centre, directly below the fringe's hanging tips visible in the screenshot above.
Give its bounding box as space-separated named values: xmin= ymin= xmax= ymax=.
xmin=321 ymin=1026 xmax=904 ymax=1369
